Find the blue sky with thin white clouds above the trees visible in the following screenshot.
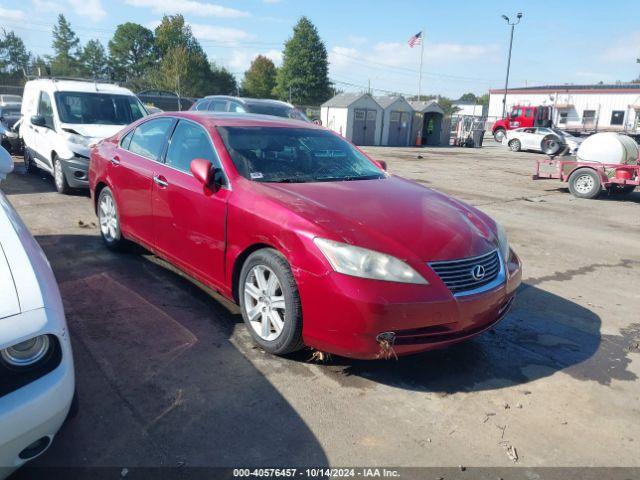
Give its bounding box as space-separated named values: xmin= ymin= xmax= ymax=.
xmin=0 ymin=0 xmax=640 ymax=98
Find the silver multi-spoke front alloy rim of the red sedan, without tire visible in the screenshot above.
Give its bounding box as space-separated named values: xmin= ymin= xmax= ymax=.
xmin=244 ymin=265 xmax=286 ymax=342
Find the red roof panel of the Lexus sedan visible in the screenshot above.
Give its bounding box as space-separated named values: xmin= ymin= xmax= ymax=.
xmin=154 ymin=110 xmax=325 ymax=130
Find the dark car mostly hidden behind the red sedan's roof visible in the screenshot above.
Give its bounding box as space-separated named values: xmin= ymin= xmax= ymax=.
xmin=190 ymin=95 xmax=311 ymax=122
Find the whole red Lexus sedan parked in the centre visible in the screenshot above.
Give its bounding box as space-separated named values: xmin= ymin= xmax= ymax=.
xmin=89 ymin=112 xmax=521 ymax=358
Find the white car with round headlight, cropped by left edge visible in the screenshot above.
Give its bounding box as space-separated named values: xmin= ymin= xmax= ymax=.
xmin=0 ymin=147 xmax=75 ymax=479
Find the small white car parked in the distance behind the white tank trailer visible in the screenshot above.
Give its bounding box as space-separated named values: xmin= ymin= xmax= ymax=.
xmin=502 ymin=127 xmax=584 ymax=155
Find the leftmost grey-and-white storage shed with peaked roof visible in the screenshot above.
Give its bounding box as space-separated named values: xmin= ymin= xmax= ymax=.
xmin=320 ymin=93 xmax=382 ymax=145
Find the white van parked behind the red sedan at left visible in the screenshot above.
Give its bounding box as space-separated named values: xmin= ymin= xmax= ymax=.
xmin=20 ymin=78 xmax=148 ymax=193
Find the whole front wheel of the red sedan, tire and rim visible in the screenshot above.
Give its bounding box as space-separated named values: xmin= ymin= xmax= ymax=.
xmin=238 ymin=248 xmax=303 ymax=355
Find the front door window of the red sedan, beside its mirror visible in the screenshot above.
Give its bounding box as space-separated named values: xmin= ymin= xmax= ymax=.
xmin=165 ymin=120 xmax=220 ymax=173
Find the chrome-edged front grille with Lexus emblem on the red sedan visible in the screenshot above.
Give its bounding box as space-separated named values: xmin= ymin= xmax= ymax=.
xmin=429 ymin=250 xmax=502 ymax=294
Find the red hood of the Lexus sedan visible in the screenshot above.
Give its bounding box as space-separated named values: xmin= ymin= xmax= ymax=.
xmin=254 ymin=176 xmax=496 ymax=261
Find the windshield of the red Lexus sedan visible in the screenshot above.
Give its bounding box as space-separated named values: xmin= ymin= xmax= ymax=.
xmin=218 ymin=127 xmax=385 ymax=183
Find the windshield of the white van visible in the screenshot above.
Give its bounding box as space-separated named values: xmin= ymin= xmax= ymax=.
xmin=55 ymin=92 xmax=146 ymax=125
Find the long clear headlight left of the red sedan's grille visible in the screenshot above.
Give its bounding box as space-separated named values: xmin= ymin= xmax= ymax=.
xmin=313 ymin=238 xmax=429 ymax=285
